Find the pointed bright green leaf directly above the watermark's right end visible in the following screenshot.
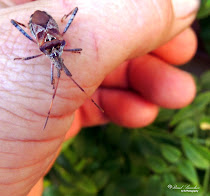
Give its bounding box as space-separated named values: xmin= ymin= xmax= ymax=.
xmin=177 ymin=159 xmax=199 ymax=185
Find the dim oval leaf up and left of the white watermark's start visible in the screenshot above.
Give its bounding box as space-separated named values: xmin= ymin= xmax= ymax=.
xmin=147 ymin=156 xmax=167 ymax=173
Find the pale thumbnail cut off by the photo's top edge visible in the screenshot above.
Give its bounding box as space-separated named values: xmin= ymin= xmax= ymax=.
xmin=172 ymin=0 xmax=200 ymax=18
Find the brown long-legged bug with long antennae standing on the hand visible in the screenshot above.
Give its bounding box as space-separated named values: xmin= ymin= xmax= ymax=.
xmin=11 ymin=7 xmax=104 ymax=130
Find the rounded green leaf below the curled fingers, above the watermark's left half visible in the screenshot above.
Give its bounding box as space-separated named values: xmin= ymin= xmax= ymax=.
xmin=161 ymin=144 xmax=181 ymax=163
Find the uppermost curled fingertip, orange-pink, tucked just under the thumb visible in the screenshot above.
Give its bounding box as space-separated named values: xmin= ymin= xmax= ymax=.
xmin=152 ymin=28 xmax=197 ymax=65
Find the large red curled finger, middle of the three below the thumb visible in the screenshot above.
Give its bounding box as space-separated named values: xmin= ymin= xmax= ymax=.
xmin=128 ymin=55 xmax=196 ymax=108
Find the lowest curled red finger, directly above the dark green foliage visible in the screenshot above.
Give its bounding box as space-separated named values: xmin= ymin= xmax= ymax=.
xmin=101 ymin=89 xmax=158 ymax=127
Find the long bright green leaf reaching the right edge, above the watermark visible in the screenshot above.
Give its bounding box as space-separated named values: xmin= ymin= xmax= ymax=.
xmin=182 ymin=139 xmax=209 ymax=169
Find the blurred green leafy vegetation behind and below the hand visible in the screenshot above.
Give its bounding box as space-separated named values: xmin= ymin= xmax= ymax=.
xmin=43 ymin=0 xmax=210 ymax=196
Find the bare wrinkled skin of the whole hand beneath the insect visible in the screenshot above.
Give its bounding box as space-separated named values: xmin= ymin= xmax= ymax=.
xmin=0 ymin=0 xmax=197 ymax=196
